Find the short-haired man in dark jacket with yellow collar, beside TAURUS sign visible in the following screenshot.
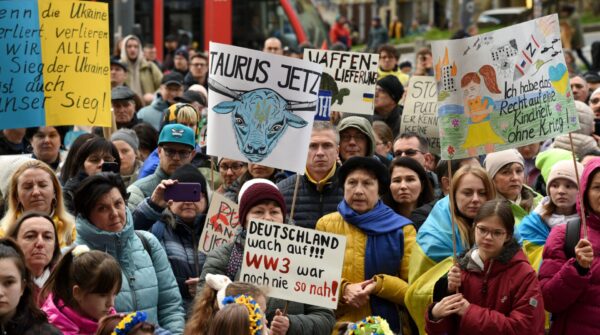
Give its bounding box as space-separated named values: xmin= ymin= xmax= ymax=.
xmin=277 ymin=121 xmax=344 ymax=229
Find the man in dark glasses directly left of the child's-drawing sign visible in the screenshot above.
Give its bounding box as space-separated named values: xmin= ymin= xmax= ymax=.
xmin=393 ymin=132 xmax=441 ymax=198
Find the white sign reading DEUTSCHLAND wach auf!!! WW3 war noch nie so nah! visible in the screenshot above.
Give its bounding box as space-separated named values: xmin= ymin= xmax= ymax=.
xmin=240 ymin=220 xmax=346 ymax=309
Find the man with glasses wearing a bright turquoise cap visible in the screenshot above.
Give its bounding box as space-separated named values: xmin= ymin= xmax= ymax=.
xmin=127 ymin=124 xmax=196 ymax=212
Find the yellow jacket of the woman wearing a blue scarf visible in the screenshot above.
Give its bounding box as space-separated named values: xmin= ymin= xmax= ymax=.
xmin=316 ymin=212 xmax=416 ymax=332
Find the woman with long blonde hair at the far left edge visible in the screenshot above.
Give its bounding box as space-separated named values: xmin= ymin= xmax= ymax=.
xmin=0 ymin=160 xmax=75 ymax=248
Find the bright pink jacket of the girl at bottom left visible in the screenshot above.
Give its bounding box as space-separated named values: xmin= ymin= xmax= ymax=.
xmin=42 ymin=294 xmax=116 ymax=335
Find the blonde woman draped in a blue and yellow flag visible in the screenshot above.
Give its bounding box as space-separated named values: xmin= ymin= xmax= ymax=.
xmin=405 ymin=165 xmax=496 ymax=333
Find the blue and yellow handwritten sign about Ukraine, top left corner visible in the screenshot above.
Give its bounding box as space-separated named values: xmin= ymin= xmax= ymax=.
xmin=0 ymin=0 xmax=111 ymax=129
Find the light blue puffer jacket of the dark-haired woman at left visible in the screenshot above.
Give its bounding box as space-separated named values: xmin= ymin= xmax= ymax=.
xmin=76 ymin=209 xmax=184 ymax=334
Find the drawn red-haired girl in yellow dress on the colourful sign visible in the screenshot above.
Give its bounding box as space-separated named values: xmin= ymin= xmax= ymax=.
xmin=460 ymin=65 xmax=504 ymax=156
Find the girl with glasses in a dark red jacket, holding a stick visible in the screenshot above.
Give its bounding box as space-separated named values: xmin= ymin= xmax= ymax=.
xmin=425 ymin=200 xmax=544 ymax=335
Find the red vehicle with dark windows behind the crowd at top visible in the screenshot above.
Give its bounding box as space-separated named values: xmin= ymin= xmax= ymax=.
xmin=121 ymin=0 xmax=328 ymax=59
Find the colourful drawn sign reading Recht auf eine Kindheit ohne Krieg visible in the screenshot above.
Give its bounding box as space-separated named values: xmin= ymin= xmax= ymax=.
xmin=432 ymin=14 xmax=579 ymax=159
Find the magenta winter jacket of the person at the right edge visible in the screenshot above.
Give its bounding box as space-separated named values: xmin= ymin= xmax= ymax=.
xmin=539 ymin=158 xmax=600 ymax=335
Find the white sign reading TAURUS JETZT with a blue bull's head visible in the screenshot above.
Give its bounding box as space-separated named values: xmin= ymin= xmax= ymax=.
xmin=207 ymin=42 xmax=323 ymax=174
